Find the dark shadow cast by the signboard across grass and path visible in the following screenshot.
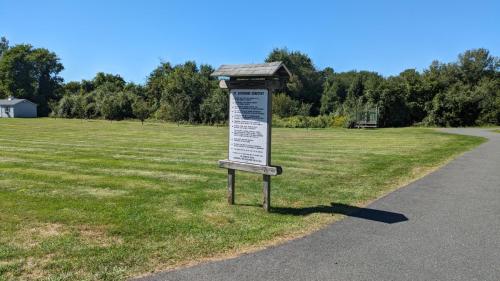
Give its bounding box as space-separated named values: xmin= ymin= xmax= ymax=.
xmin=271 ymin=203 xmax=408 ymax=224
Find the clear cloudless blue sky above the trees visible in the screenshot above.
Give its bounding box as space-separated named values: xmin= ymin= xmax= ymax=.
xmin=0 ymin=0 xmax=500 ymax=83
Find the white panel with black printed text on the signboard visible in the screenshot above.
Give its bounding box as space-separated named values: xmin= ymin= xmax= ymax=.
xmin=229 ymin=89 xmax=268 ymax=166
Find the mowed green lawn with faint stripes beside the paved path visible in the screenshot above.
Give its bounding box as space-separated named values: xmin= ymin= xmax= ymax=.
xmin=0 ymin=119 xmax=484 ymax=280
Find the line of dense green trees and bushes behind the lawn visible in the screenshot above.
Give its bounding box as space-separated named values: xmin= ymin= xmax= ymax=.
xmin=0 ymin=37 xmax=500 ymax=127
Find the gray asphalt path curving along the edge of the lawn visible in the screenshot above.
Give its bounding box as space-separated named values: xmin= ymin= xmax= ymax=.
xmin=136 ymin=129 xmax=500 ymax=281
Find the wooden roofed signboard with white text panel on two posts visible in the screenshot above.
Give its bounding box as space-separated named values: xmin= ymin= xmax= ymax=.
xmin=212 ymin=62 xmax=291 ymax=211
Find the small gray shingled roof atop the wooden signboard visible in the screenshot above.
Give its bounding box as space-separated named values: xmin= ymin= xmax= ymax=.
xmin=212 ymin=61 xmax=291 ymax=77
